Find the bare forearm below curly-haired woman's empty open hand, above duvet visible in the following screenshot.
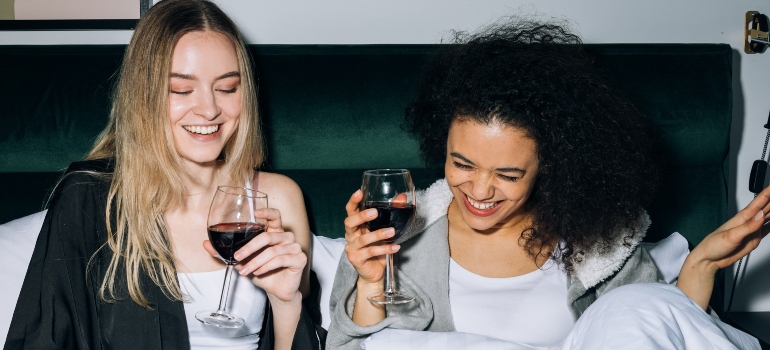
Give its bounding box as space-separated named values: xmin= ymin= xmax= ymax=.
xmin=676 ymin=254 xmax=718 ymax=310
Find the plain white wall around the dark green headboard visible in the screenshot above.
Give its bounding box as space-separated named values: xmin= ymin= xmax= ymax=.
xmin=0 ymin=0 xmax=770 ymax=311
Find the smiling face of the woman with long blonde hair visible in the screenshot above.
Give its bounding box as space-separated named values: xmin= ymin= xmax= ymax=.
xmin=168 ymin=31 xmax=242 ymax=165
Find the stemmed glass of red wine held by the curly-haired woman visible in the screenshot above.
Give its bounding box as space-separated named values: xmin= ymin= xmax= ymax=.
xmin=361 ymin=169 xmax=416 ymax=305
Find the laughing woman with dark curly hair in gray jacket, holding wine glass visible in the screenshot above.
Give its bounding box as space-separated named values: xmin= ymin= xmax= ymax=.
xmin=328 ymin=22 xmax=770 ymax=349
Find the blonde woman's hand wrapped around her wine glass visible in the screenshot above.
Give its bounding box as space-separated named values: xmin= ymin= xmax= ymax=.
xmin=203 ymin=208 xmax=307 ymax=302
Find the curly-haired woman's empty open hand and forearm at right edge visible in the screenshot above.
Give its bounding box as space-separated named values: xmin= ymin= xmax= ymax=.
xmin=677 ymin=187 xmax=770 ymax=309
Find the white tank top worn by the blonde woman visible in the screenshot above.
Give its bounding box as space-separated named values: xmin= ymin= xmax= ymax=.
xmin=177 ymin=269 xmax=267 ymax=350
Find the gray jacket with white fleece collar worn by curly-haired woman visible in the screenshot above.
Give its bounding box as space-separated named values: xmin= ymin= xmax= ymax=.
xmin=326 ymin=180 xmax=658 ymax=350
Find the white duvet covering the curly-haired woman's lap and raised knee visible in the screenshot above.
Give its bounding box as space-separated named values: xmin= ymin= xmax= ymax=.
xmin=361 ymin=283 xmax=760 ymax=350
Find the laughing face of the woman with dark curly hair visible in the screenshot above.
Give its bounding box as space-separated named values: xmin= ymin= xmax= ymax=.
xmin=444 ymin=120 xmax=538 ymax=231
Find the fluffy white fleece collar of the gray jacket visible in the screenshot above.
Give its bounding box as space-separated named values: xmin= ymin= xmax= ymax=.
xmin=399 ymin=179 xmax=650 ymax=289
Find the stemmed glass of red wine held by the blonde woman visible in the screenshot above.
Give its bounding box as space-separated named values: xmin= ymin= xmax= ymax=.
xmin=195 ymin=186 xmax=267 ymax=328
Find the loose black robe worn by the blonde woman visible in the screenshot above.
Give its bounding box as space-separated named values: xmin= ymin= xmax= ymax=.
xmin=4 ymin=161 xmax=325 ymax=350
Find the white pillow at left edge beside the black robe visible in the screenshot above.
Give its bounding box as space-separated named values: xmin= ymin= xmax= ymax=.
xmin=0 ymin=210 xmax=48 ymax=344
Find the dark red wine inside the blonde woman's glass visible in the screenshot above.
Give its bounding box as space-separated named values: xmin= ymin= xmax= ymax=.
xmin=209 ymin=222 xmax=265 ymax=264
